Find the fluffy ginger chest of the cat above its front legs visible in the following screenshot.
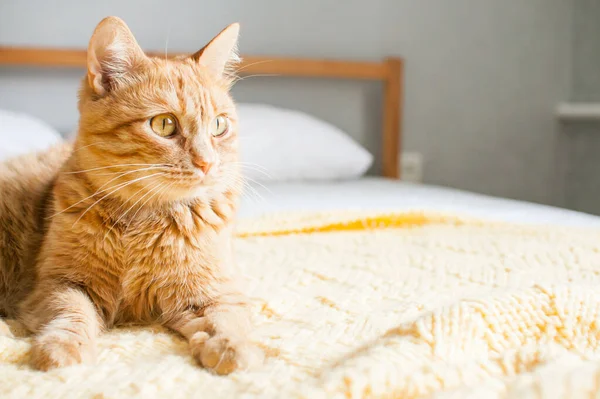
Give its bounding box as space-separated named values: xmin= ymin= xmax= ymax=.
xmin=88 ymin=204 xmax=236 ymax=324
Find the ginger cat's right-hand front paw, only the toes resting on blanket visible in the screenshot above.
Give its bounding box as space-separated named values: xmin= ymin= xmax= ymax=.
xmin=190 ymin=332 xmax=264 ymax=375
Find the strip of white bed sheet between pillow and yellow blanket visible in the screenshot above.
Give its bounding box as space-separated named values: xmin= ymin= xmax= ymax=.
xmin=240 ymin=177 xmax=600 ymax=227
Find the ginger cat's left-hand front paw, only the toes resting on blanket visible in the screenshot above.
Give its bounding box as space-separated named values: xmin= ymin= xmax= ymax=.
xmin=31 ymin=334 xmax=96 ymax=371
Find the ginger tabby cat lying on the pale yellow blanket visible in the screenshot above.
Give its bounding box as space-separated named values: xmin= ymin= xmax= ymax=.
xmin=0 ymin=17 xmax=263 ymax=374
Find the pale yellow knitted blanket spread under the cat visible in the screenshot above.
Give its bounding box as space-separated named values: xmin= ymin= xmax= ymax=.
xmin=0 ymin=213 xmax=600 ymax=399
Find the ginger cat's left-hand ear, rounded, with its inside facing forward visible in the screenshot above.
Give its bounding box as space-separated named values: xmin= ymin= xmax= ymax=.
xmin=87 ymin=17 xmax=148 ymax=95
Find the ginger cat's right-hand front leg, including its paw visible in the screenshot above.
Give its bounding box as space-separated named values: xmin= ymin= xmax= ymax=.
xmin=168 ymin=294 xmax=264 ymax=375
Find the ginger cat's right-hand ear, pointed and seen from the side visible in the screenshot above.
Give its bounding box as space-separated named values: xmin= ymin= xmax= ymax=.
xmin=192 ymin=23 xmax=240 ymax=77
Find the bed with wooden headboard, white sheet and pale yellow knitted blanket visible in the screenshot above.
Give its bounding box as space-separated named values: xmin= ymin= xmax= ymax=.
xmin=0 ymin=48 xmax=600 ymax=398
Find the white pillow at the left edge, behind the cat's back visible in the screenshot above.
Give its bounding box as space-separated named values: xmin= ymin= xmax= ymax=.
xmin=0 ymin=109 xmax=61 ymax=161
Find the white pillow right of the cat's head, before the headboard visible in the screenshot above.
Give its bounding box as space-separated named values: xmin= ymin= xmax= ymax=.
xmin=238 ymin=103 xmax=373 ymax=181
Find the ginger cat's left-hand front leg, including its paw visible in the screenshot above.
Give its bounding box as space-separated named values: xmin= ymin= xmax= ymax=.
xmin=20 ymin=287 xmax=101 ymax=370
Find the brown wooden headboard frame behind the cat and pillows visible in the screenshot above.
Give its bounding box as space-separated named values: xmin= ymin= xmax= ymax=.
xmin=0 ymin=47 xmax=404 ymax=178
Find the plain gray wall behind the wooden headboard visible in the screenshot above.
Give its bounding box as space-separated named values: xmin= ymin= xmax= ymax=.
xmin=0 ymin=0 xmax=572 ymax=203
